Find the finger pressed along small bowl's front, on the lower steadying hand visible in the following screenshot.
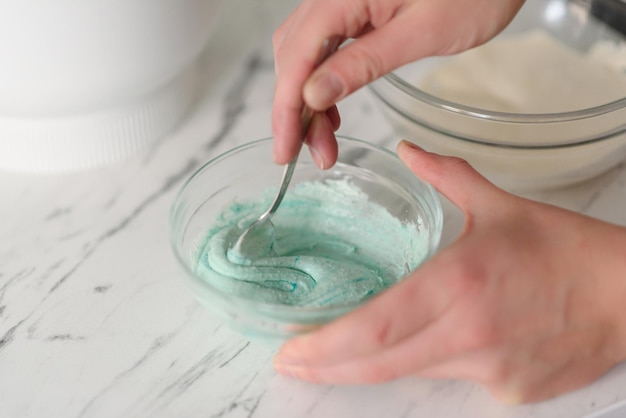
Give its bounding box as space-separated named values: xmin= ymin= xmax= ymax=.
xmin=275 ymin=251 xmax=454 ymax=366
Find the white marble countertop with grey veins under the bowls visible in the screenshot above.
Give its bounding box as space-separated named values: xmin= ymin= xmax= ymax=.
xmin=0 ymin=0 xmax=626 ymax=418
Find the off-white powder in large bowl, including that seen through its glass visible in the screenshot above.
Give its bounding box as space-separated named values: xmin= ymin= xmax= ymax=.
xmin=380 ymin=30 xmax=626 ymax=190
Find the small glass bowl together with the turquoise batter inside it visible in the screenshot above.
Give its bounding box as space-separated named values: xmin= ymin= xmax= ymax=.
xmin=169 ymin=136 xmax=443 ymax=342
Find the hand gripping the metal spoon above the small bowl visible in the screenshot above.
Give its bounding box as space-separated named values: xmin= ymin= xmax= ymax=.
xmin=272 ymin=0 xmax=523 ymax=168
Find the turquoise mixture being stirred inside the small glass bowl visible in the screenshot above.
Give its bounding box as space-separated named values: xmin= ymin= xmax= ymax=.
xmin=194 ymin=179 xmax=426 ymax=306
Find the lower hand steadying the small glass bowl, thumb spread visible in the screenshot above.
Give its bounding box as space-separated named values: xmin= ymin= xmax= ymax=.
xmin=275 ymin=142 xmax=626 ymax=403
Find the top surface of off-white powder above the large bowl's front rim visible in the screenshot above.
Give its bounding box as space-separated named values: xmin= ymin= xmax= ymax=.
xmin=420 ymin=30 xmax=626 ymax=113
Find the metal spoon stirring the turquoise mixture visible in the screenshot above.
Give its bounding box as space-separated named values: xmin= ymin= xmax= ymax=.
xmin=231 ymin=38 xmax=341 ymax=254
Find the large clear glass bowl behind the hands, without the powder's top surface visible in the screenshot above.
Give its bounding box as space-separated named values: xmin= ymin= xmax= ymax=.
xmin=371 ymin=0 xmax=626 ymax=190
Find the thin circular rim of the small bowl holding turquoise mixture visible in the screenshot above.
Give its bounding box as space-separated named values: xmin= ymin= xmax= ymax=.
xmin=168 ymin=135 xmax=443 ymax=315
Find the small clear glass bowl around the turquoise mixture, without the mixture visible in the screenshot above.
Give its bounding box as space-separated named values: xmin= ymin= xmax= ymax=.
xmin=169 ymin=137 xmax=443 ymax=340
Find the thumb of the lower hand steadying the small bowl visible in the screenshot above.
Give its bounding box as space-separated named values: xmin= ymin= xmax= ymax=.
xmin=398 ymin=140 xmax=505 ymax=215
